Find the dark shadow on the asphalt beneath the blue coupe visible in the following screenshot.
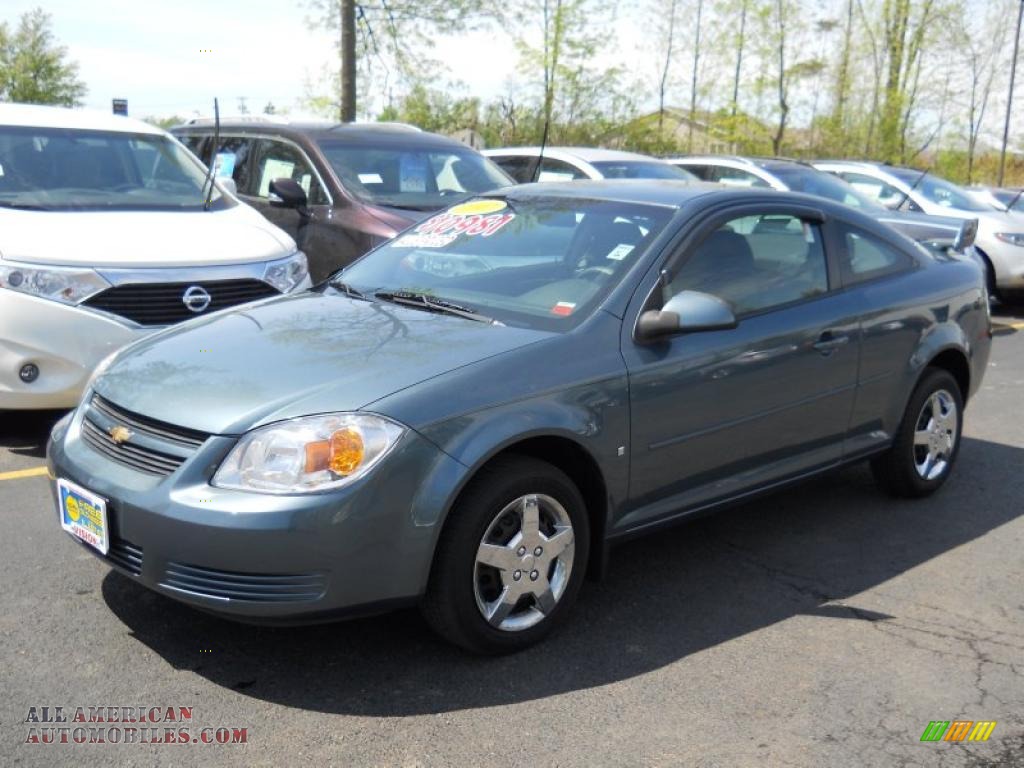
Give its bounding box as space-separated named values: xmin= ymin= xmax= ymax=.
xmin=102 ymin=439 xmax=1024 ymax=717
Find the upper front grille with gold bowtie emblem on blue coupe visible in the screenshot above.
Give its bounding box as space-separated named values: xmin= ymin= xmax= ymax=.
xmin=82 ymin=394 xmax=208 ymax=477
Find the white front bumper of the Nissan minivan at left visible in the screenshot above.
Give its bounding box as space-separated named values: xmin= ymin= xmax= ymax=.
xmin=0 ymin=290 xmax=149 ymax=411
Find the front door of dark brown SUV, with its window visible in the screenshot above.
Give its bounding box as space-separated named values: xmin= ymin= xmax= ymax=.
xmin=246 ymin=138 xmax=352 ymax=283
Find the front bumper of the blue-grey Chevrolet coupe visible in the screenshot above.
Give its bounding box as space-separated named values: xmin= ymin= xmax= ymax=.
xmin=47 ymin=409 xmax=465 ymax=624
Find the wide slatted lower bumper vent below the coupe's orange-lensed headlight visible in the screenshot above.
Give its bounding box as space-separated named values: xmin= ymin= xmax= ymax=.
xmin=161 ymin=562 xmax=327 ymax=603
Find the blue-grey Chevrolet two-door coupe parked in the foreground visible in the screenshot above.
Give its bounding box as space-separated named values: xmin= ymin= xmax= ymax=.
xmin=48 ymin=181 xmax=991 ymax=653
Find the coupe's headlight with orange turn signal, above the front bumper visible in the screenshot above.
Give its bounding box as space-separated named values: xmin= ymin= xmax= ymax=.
xmin=211 ymin=414 xmax=406 ymax=494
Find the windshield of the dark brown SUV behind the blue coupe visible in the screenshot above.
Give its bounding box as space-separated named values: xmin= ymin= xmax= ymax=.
xmin=319 ymin=141 xmax=514 ymax=211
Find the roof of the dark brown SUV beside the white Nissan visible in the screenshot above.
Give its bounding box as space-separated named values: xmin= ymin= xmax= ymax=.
xmin=171 ymin=116 xmax=469 ymax=150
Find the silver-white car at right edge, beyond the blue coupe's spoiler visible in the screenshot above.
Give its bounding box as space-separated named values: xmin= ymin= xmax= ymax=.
xmin=814 ymin=160 xmax=1024 ymax=301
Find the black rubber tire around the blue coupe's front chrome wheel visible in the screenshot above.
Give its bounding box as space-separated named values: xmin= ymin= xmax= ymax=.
xmin=421 ymin=456 xmax=590 ymax=654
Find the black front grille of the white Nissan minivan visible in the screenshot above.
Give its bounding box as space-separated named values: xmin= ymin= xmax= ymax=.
xmin=85 ymin=279 xmax=278 ymax=326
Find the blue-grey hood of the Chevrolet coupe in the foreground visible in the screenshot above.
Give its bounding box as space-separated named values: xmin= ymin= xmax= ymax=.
xmin=94 ymin=292 xmax=550 ymax=434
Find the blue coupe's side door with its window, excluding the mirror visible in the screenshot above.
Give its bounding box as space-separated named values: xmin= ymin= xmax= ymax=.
xmin=620 ymin=204 xmax=859 ymax=527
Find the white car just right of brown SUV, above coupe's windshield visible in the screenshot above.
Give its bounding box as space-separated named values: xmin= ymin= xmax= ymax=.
xmin=483 ymin=146 xmax=697 ymax=184
